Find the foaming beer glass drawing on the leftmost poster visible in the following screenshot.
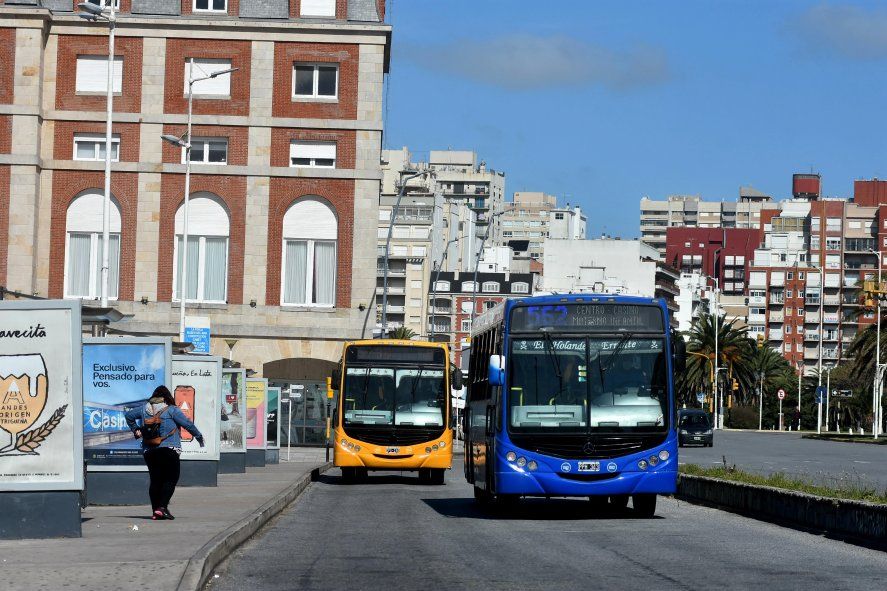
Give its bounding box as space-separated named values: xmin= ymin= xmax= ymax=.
xmin=0 ymin=353 xmax=48 ymax=452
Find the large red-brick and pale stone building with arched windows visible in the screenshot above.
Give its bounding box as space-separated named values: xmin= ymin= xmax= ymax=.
xmin=0 ymin=0 xmax=391 ymax=379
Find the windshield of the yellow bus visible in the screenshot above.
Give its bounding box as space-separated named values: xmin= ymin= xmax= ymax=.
xmin=343 ymin=366 xmax=446 ymax=427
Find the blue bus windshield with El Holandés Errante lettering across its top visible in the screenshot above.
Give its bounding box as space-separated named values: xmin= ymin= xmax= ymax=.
xmin=506 ymin=340 xmax=668 ymax=432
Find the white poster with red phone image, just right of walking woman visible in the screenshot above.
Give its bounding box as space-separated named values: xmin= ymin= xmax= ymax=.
xmin=170 ymin=355 xmax=222 ymax=460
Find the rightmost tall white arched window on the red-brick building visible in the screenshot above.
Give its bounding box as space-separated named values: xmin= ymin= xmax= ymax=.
xmin=280 ymin=197 xmax=339 ymax=306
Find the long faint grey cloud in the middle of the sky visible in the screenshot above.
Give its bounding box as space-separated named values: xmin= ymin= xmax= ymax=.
xmin=398 ymin=34 xmax=670 ymax=90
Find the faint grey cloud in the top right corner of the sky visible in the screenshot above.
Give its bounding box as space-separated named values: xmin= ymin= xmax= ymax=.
xmin=792 ymin=3 xmax=887 ymax=60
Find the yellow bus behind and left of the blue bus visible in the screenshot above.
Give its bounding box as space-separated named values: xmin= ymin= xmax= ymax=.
xmin=332 ymin=339 xmax=462 ymax=484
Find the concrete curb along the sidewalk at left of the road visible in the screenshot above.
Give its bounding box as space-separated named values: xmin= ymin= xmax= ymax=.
xmin=176 ymin=462 xmax=333 ymax=591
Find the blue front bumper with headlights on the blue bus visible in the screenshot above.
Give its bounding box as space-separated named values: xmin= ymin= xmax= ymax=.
xmin=495 ymin=440 xmax=678 ymax=496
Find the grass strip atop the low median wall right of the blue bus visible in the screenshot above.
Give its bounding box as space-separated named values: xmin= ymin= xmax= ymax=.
xmin=680 ymin=464 xmax=887 ymax=505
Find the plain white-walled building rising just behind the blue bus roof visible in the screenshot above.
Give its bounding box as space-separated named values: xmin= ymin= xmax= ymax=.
xmin=541 ymin=239 xmax=680 ymax=322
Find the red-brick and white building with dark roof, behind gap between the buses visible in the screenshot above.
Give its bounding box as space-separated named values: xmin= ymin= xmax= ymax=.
xmin=428 ymin=271 xmax=533 ymax=365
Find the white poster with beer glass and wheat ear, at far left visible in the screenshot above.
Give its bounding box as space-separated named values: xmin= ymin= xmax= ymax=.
xmin=0 ymin=301 xmax=83 ymax=491
